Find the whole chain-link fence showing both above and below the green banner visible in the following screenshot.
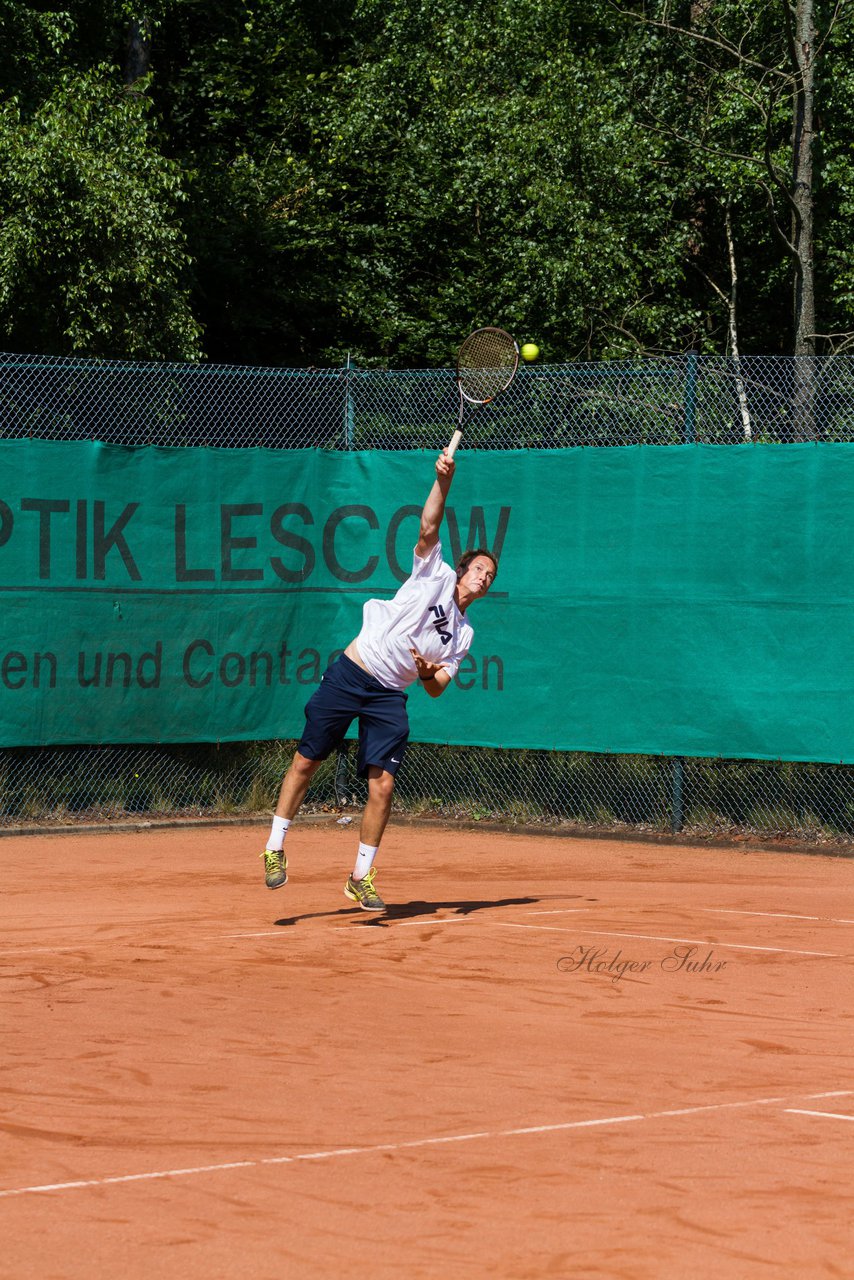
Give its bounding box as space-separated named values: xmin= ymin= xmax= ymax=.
xmin=0 ymin=353 xmax=854 ymax=847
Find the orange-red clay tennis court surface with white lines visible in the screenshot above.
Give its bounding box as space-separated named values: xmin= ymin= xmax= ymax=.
xmin=0 ymin=818 xmax=854 ymax=1280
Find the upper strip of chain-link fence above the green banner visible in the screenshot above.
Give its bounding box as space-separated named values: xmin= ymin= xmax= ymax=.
xmin=0 ymin=355 xmax=854 ymax=449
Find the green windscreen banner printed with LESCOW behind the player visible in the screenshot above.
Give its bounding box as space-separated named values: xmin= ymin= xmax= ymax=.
xmin=0 ymin=440 xmax=854 ymax=763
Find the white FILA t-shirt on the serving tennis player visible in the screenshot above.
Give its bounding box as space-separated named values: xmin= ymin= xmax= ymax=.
xmin=356 ymin=543 xmax=474 ymax=689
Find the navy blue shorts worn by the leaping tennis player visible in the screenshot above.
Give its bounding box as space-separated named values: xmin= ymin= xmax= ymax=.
xmin=297 ymin=653 xmax=410 ymax=777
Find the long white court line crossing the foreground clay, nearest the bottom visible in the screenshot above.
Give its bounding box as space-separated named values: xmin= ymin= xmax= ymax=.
xmin=0 ymin=1089 xmax=854 ymax=1198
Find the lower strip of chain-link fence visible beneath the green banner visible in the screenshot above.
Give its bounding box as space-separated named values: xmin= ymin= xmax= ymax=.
xmin=0 ymin=741 xmax=854 ymax=849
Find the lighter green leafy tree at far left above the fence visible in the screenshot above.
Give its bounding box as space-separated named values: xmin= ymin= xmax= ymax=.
xmin=0 ymin=70 xmax=198 ymax=358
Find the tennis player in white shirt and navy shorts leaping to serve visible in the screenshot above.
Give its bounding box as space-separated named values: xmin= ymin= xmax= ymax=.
xmin=261 ymin=449 xmax=498 ymax=911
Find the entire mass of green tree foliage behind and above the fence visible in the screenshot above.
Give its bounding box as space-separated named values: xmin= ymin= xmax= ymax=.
xmin=0 ymin=0 xmax=854 ymax=366
